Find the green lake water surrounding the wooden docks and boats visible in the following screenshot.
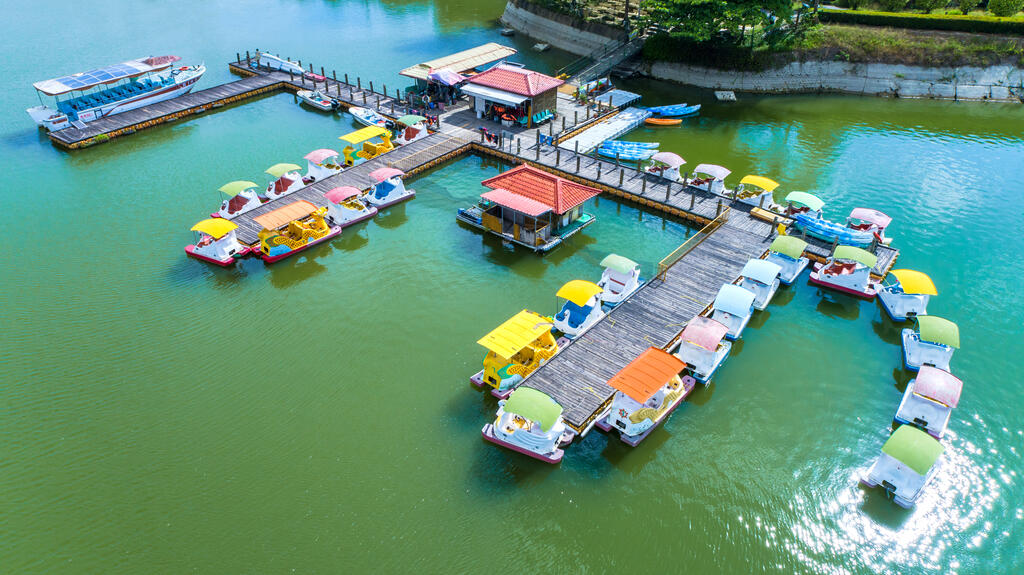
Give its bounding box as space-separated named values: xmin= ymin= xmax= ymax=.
xmin=0 ymin=0 xmax=1024 ymax=574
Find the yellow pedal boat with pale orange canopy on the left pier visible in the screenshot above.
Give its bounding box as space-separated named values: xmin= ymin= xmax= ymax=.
xmin=253 ymin=200 xmax=341 ymax=264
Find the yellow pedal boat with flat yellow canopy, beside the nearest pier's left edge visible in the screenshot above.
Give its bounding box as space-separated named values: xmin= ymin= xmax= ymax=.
xmin=469 ymin=310 xmax=558 ymax=399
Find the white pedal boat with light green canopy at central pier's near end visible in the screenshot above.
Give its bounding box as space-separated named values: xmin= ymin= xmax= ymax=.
xmin=480 ymin=387 xmax=575 ymax=463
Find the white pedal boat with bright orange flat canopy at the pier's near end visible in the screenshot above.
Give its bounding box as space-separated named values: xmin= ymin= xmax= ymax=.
xmin=597 ymin=347 xmax=696 ymax=447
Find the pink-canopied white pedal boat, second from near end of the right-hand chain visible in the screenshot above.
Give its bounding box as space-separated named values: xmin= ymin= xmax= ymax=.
xmin=893 ymin=365 xmax=964 ymax=439
